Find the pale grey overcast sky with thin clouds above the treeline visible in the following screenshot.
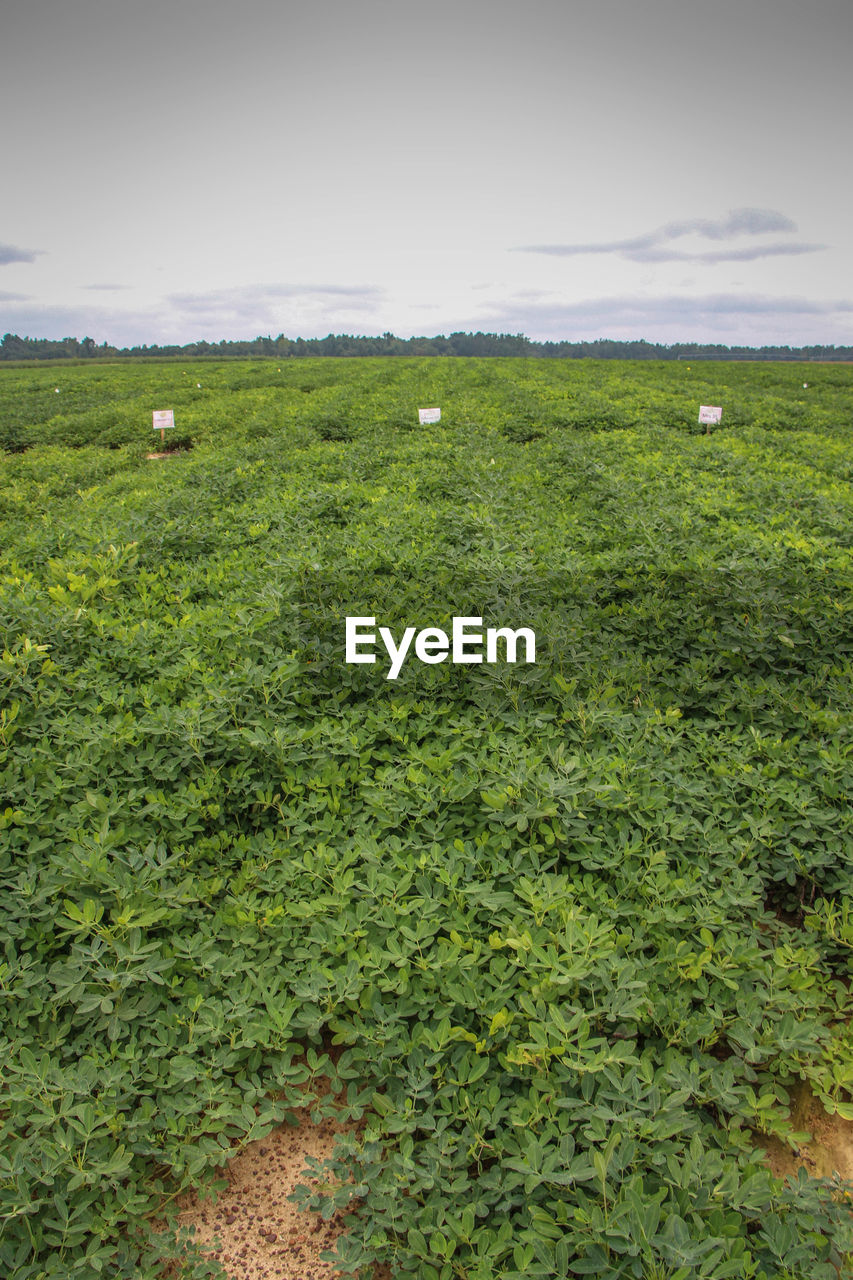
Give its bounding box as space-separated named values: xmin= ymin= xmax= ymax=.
xmin=0 ymin=0 xmax=853 ymax=346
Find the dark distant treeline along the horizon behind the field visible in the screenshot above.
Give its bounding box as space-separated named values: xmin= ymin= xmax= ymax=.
xmin=0 ymin=333 xmax=853 ymax=361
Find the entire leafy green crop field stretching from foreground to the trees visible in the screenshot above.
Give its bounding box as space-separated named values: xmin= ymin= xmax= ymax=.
xmin=0 ymin=358 xmax=853 ymax=1280
